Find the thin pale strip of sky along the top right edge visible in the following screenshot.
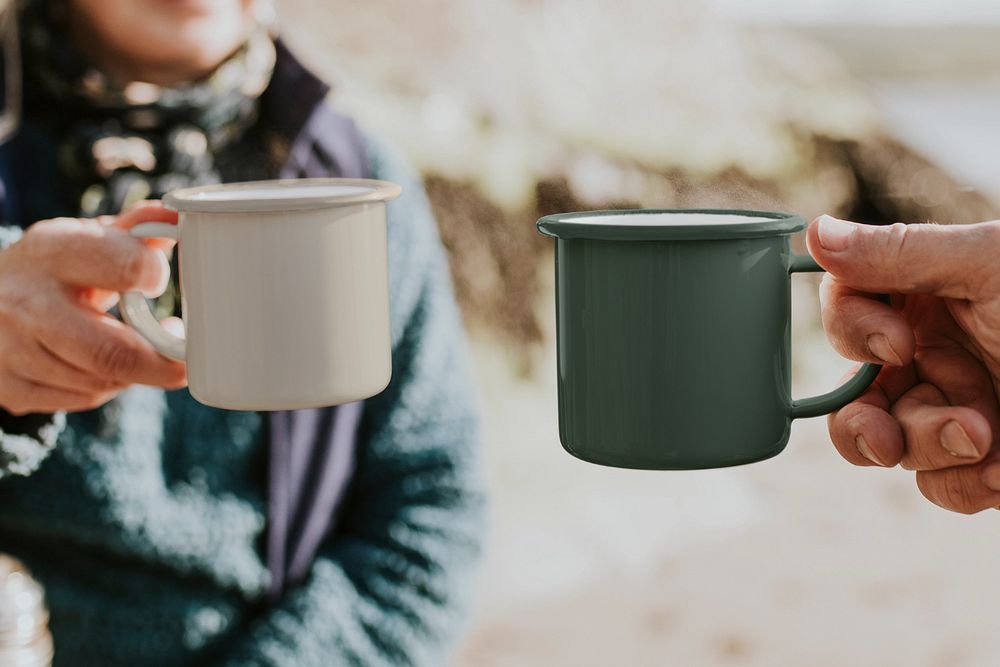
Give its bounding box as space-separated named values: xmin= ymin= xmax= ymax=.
xmin=708 ymin=0 xmax=1000 ymax=26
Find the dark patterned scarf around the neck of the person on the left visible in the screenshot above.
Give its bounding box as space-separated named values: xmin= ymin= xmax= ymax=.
xmin=20 ymin=0 xmax=275 ymax=218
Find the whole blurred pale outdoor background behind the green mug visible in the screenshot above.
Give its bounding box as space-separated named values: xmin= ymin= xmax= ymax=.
xmin=279 ymin=0 xmax=1000 ymax=667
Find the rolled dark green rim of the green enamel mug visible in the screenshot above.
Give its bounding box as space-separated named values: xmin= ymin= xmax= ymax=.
xmin=536 ymin=208 xmax=806 ymax=241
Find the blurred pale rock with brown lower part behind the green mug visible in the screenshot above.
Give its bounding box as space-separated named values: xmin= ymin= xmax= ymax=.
xmin=280 ymin=0 xmax=996 ymax=360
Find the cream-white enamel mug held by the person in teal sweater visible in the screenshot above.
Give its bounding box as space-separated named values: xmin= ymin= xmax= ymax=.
xmin=120 ymin=178 xmax=401 ymax=410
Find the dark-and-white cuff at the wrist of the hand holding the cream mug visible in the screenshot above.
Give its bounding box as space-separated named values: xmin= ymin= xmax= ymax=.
xmin=0 ymin=226 xmax=66 ymax=479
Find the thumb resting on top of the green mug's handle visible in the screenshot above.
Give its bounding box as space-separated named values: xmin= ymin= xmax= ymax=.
xmin=806 ymin=215 xmax=1000 ymax=300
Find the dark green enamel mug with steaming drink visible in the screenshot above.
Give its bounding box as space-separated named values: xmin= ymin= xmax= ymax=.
xmin=538 ymin=209 xmax=881 ymax=470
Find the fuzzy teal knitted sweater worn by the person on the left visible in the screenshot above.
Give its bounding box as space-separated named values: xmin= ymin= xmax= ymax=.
xmin=0 ymin=138 xmax=484 ymax=667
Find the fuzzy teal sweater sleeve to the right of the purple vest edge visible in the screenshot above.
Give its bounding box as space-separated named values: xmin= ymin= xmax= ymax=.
xmin=216 ymin=138 xmax=485 ymax=667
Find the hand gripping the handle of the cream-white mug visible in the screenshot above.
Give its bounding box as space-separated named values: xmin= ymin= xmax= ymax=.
xmin=0 ymin=204 xmax=186 ymax=415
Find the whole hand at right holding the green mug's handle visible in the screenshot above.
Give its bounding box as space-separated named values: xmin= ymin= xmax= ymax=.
xmin=807 ymin=216 xmax=1000 ymax=514
